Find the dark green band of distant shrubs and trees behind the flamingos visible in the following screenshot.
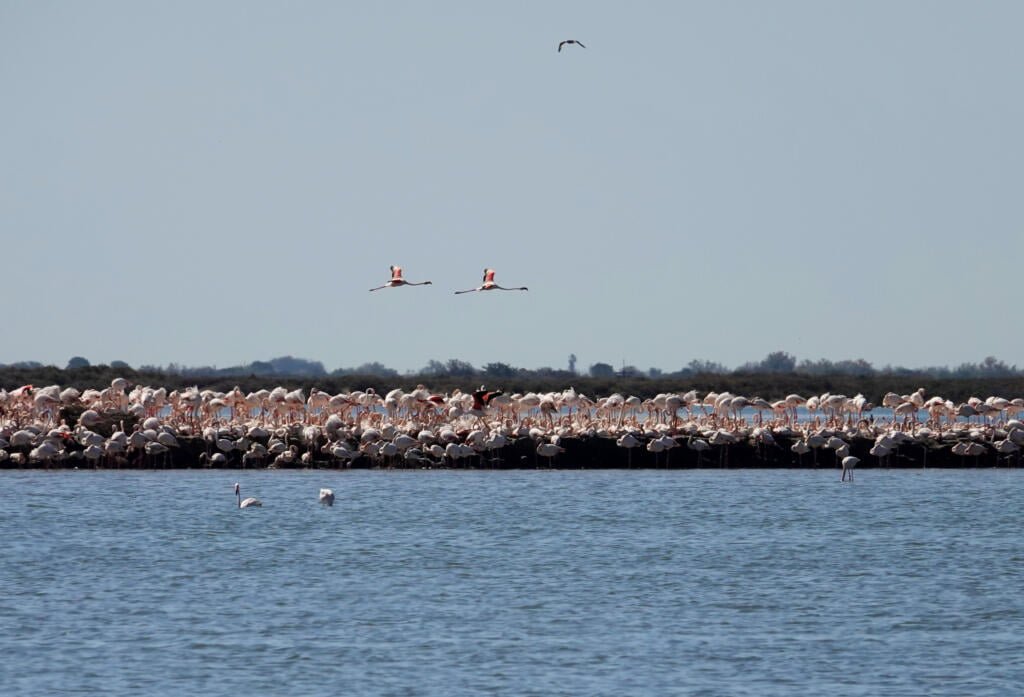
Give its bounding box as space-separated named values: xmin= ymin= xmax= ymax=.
xmin=0 ymin=351 xmax=1024 ymax=401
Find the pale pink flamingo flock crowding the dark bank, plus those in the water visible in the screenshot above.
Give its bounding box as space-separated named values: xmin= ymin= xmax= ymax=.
xmin=0 ymin=378 xmax=1024 ymax=487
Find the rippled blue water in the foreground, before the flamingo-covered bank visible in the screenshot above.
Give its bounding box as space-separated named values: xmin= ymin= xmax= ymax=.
xmin=0 ymin=470 xmax=1024 ymax=697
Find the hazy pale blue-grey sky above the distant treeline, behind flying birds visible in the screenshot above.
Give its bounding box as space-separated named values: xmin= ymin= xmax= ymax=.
xmin=0 ymin=0 xmax=1024 ymax=371
